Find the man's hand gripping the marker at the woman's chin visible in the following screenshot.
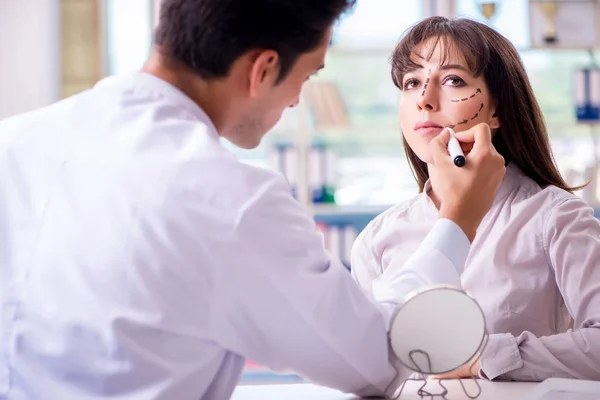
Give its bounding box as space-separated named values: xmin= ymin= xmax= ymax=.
xmin=429 ymin=123 xmax=506 ymax=241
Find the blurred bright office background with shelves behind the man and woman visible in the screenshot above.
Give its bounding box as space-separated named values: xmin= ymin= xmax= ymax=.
xmin=0 ymin=0 xmax=600 ymax=388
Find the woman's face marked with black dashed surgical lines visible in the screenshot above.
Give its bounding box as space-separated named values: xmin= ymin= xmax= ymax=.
xmin=400 ymin=39 xmax=500 ymax=163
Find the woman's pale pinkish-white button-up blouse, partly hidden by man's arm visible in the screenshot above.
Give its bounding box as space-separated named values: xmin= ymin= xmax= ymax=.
xmin=351 ymin=165 xmax=600 ymax=381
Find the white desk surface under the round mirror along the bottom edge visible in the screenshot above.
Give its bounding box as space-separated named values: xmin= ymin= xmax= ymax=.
xmin=231 ymin=380 xmax=537 ymax=400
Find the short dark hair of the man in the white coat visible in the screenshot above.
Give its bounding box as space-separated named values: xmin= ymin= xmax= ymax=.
xmin=154 ymin=0 xmax=356 ymax=81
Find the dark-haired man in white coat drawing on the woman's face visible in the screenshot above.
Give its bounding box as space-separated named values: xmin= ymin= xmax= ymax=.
xmin=0 ymin=0 xmax=504 ymax=400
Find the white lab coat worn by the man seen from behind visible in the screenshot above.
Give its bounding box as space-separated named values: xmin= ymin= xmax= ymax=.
xmin=0 ymin=73 xmax=468 ymax=400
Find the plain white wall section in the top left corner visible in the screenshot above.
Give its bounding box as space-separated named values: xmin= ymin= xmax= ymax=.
xmin=0 ymin=0 xmax=61 ymax=119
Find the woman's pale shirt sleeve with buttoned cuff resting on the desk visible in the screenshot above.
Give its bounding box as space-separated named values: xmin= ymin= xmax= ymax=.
xmin=481 ymin=197 xmax=600 ymax=381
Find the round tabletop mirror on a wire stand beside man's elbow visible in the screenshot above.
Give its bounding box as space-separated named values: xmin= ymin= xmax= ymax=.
xmin=390 ymin=286 xmax=486 ymax=375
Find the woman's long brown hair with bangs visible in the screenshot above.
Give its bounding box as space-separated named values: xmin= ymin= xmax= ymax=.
xmin=391 ymin=17 xmax=581 ymax=192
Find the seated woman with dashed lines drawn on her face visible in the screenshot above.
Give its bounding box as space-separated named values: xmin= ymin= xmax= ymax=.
xmin=351 ymin=17 xmax=600 ymax=381
